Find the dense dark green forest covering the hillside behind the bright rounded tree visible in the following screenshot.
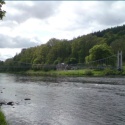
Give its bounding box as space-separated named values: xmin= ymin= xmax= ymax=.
xmin=0 ymin=25 xmax=125 ymax=71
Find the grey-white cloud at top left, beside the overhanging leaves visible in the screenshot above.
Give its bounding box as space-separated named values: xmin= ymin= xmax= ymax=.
xmin=5 ymin=1 xmax=61 ymax=23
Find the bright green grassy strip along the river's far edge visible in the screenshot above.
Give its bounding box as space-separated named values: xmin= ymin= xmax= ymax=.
xmin=18 ymin=69 xmax=125 ymax=77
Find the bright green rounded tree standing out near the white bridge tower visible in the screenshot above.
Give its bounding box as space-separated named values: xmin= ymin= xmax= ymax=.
xmin=86 ymin=43 xmax=113 ymax=63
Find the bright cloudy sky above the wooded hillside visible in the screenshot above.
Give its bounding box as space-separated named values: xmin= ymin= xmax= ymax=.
xmin=0 ymin=1 xmax=125 ymax=61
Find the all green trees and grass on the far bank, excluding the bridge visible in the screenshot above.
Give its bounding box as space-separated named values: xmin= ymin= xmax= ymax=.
xmin=0 ymin=25 xmax=125 ymax=76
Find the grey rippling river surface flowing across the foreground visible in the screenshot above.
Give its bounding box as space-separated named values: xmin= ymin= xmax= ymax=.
xmin=0 ymin=74 xmax=125 ymax=125
